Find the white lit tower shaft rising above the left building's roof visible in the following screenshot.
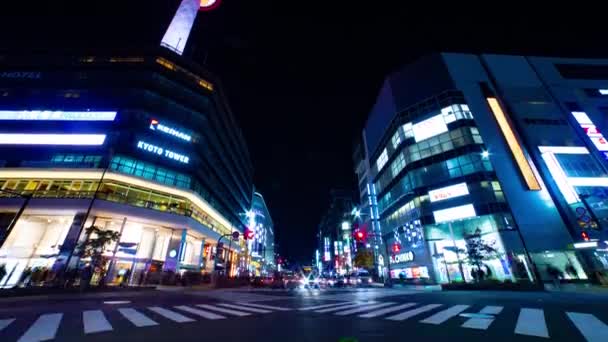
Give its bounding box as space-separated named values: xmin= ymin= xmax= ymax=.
xmin=160 ymin=0 xmax=221 ymax=55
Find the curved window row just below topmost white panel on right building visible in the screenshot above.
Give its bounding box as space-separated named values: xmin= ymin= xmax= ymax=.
xmin=376 ymin=127 xmax=483 ymax=192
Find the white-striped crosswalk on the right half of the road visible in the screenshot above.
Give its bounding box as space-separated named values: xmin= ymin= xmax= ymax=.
xmin=299 ymin=301 xmax=608 ymax=342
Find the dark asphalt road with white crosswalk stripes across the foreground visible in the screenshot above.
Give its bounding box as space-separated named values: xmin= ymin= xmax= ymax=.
xmin=0 ymin=289 xmax=608 ymax=342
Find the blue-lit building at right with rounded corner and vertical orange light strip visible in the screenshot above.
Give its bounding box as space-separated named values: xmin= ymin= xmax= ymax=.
xmin=360 ymin=53 xmax=608 ymax=283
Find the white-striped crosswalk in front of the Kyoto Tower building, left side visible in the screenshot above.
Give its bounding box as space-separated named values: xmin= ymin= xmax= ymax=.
xmin=0 ymin=302 xmax=291 ymax=342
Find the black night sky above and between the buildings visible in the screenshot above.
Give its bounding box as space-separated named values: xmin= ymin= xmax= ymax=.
xmin=0 ymin=0 xmax=608 ymax=263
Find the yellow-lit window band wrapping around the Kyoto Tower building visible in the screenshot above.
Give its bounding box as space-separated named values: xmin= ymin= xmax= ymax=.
xmin=0 ymin=179 xmax=230 ymax=234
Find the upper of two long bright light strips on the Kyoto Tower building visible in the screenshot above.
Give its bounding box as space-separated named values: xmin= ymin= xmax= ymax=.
xmin=0 ymin=110 xmax=116 ymax=121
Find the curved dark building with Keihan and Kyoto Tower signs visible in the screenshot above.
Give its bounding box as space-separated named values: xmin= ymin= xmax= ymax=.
xmin=0 ymin=48 xmax=253 ymax=287
